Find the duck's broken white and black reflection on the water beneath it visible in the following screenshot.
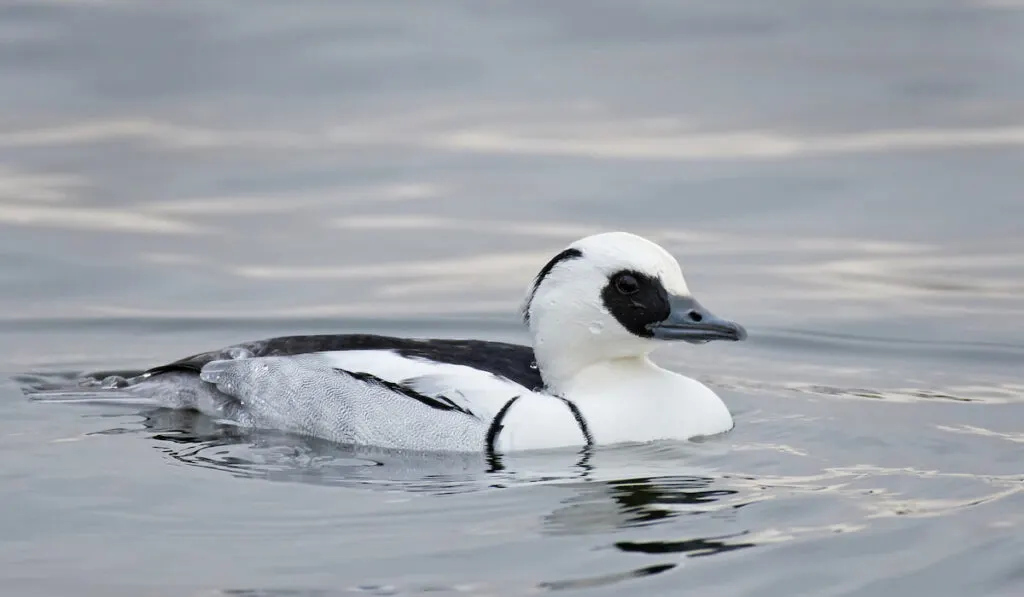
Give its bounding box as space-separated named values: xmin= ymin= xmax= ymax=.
xmin=94 ymin=397 xmax=770 ymax=569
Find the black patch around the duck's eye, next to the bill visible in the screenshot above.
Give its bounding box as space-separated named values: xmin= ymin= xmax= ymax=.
xmin=601 ymin=269 xmax=672 ymax=338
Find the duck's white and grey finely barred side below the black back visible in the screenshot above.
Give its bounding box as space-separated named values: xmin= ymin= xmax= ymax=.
xmin=191 ymin=350 xmax=532 ymax=451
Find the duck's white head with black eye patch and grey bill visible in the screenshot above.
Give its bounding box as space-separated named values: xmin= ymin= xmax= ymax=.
xmin=522 ymin=232 xmax=746 ymax=392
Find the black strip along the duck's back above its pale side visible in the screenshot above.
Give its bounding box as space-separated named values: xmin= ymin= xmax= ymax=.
xmin=147 ymin=334 xmax=544 ymax=389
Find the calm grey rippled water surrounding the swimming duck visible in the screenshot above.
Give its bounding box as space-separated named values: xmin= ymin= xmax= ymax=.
xmin=0 ymin=0 xmax=1024 ymax=597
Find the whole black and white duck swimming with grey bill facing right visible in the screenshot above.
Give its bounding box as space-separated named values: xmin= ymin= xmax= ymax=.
xmin=25 ymin=231 xmax=746 ymax=453
